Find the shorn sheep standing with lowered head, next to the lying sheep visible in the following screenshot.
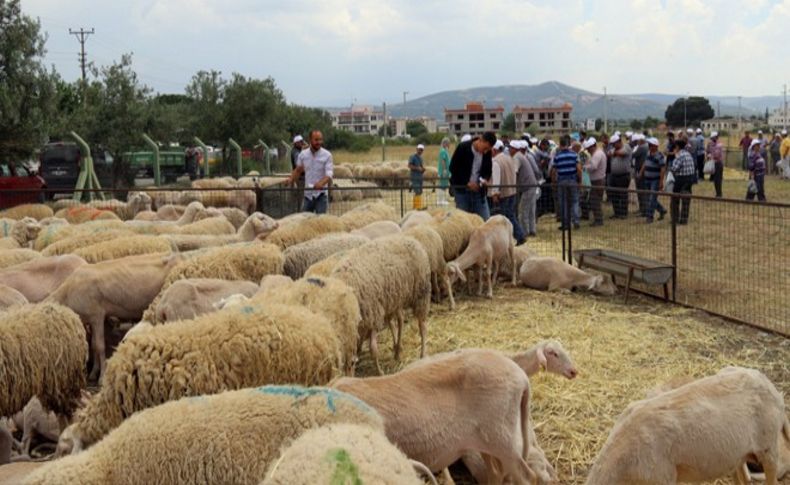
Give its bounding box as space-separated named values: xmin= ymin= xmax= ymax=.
xmin=447 ymin=215 xmax=516 ymax=298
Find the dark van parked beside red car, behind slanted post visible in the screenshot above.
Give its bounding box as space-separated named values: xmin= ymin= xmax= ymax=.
xmin=39 ymin=142 xmax=113 ymax=198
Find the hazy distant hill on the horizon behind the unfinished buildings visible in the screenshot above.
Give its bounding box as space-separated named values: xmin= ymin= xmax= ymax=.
xmin=378 ymin=81 xmax=781 ymax=121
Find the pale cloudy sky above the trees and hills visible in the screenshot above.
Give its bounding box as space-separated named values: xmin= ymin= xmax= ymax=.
xmin=22 ymin=0 xmax=790 ymax=106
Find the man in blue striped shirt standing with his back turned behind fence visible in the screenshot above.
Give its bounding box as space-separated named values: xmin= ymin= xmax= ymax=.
xmin=551 ymin=135 xmax=582 ymax=231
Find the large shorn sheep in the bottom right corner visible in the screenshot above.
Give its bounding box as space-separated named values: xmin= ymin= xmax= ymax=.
xmin=586 ymin=367 xmax=790 ymax=485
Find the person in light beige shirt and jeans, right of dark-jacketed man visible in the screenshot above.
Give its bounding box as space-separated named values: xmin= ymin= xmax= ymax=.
xmin=489 ymin=140 xmax=526 ymax=244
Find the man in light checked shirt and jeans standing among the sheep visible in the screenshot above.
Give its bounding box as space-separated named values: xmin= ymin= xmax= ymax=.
xmin=288 ymin=130 xmax=334 ymax=214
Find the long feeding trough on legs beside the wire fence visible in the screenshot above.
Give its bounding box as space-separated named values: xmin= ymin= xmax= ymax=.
xmin=573 ymin=249 xmax=675 ymax=302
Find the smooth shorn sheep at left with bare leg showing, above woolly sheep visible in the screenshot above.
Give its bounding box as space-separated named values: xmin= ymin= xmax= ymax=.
xmin=48 ymin=254 xmax=181 ymax=379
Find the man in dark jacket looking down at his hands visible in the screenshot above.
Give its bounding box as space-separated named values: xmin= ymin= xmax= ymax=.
xmin=450 ymin=131 xmax=496 ymax=220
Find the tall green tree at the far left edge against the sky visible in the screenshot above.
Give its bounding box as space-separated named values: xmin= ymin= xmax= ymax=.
xmin=0 ymin=0 xmax=58 ymax=159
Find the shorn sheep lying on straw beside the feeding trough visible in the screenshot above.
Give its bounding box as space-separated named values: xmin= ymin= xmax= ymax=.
xmin=519 ymin=257 xmax=617 ymax=295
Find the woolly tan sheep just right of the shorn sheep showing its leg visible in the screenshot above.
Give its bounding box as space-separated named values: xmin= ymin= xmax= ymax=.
xmin=142 ymin=241 xmax=283 ymax=324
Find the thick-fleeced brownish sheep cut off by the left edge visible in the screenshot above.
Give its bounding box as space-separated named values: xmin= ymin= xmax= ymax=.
xmin=0 ymin=303 xmax=88 ymax=416
